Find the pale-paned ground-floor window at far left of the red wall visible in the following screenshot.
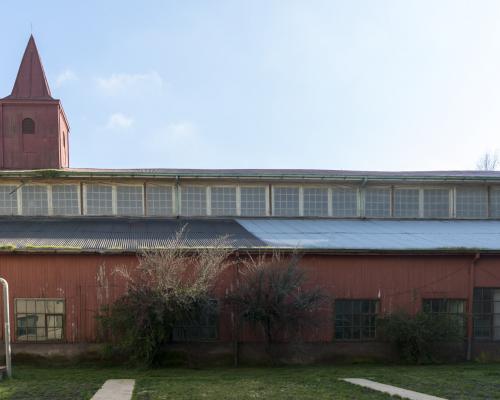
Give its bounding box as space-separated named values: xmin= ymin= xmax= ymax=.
xmin=14 ymin=299 xmax=65 ymax=342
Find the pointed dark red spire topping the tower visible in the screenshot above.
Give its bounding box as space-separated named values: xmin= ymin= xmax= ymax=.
xmin=7 ymin=35 xmax=52 ymax=100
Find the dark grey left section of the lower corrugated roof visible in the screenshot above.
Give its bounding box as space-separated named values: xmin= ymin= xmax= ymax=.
xmin=0 ymin=217 xmax=266 ymax=252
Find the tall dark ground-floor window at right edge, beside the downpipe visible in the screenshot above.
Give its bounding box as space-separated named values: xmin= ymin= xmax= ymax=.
xmin=473 ymin=288 xmax=500 ymax=340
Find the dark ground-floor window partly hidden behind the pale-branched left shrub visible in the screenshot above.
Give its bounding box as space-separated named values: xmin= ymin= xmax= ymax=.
xmin=172 ymin=300 xmax=219 ymax=342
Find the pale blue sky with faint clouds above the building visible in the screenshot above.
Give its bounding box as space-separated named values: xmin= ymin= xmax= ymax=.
xmin=0 ymin=0 xmax=500 ymax=170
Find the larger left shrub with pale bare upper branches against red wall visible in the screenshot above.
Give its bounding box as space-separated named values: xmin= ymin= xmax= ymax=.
xmin=101 ymin=225 xmax=231 ymax=365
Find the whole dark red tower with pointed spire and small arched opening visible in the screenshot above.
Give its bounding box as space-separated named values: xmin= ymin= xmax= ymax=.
xmin=0 ymin=35 xmax=69 ymax=170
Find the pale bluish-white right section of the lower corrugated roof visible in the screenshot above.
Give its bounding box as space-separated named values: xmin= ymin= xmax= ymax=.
xmin=238 ymin=219 xmax=500 ymax=251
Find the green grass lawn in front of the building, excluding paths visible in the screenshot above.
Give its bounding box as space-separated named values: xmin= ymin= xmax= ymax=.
xmin=0 ymin=364 xmax=500 ymax=400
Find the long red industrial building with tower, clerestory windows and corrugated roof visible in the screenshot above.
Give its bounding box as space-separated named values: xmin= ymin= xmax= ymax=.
xmin=0 ymin=37 xmax=500 ymax=360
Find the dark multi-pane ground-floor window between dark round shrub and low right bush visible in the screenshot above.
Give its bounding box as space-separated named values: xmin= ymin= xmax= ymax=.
xmin=334 ymin=300 xmax=379 ymax=340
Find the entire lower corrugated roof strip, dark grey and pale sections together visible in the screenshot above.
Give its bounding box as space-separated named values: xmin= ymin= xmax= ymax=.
xmin=0 ymin=217 xmax=500 ymax=252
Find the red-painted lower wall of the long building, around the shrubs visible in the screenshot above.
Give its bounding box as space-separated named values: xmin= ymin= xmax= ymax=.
xmin=0 ymin=254 xmax=500 ymax=354
